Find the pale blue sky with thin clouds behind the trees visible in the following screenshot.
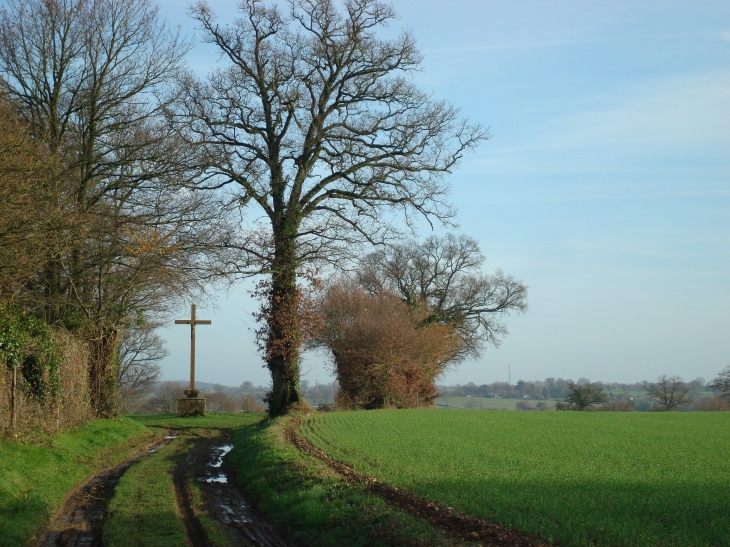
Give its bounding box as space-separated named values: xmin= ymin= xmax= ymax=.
xmin=151 ymin=0 xmax=730 ymax=385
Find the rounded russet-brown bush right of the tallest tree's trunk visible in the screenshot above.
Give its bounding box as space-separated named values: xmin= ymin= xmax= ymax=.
xmin=317 ymin=280 xmax=458 ymax=409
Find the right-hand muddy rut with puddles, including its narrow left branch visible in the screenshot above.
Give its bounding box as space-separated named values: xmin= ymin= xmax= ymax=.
xmin=174 ymin=434 xmax=297 ymax=547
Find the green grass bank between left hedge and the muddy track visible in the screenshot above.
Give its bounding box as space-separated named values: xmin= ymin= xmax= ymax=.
xmin=0 ymin=418 xmax=152 ymax=546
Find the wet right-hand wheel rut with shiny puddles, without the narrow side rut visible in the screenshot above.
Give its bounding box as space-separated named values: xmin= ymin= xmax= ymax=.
xmin=176 ymin=437 xmax=297 ymax=547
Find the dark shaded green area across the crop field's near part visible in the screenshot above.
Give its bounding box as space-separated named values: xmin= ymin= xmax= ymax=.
xmin=416 ymin=478 xmax=730 ymax=547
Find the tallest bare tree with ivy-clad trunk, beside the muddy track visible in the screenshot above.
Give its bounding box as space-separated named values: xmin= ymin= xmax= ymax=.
xmin=185 ymin=0 xmax=487 ymax=415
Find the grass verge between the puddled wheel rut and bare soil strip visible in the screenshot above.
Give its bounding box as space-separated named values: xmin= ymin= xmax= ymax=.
xmin=226 ymin=418 xmax=470 ymax=547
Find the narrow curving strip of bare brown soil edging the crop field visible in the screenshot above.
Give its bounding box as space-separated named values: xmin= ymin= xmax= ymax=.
xmin=285 ymin=418 xmax=550 ymax=547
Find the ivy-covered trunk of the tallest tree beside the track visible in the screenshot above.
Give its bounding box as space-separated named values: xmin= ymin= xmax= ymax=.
xmin=266 ymin=238 xmax=302 ymax=417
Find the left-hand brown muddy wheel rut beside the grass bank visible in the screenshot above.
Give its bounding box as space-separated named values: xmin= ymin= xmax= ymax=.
xmin=34 ymin=435 xmax=175 ymax=547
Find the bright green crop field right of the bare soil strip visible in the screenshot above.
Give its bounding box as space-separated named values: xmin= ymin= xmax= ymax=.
xmin=301 ymin=410 xmax=730 ymax=547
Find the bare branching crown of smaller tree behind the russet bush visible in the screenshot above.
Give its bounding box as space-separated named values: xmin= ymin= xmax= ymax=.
xmin=358 ymin=234 xmax=527 ymax=360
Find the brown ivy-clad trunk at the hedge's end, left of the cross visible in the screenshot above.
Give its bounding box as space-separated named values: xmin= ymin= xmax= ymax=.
xmin=89 ymin=327 xmax=119 ymax=418
